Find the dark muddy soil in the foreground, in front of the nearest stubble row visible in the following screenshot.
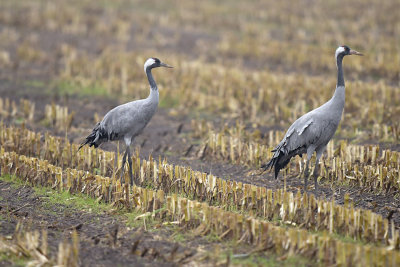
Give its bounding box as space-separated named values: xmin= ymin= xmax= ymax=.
xmin=0 ymin=181 xmax=197 ymax=266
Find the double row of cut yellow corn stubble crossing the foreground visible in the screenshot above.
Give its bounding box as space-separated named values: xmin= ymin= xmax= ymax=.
xmin=0 ymin=126 xmax=400 ymax=264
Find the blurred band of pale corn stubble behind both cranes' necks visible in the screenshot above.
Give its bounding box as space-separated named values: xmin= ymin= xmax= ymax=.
xmin=59 ymin=48 xmax=400 ymax=141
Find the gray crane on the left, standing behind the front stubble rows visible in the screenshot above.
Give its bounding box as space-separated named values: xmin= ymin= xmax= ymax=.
xmin=78 ymin=58 xmax=172 ymax=185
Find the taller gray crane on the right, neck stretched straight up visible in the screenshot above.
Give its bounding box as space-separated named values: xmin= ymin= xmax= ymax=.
xmin=261 ymin=45 xmax=362 ymax=191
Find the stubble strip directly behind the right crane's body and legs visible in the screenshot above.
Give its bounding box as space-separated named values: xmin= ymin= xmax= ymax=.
xmin=192 ymin=121 xmax=400 ymax=193
